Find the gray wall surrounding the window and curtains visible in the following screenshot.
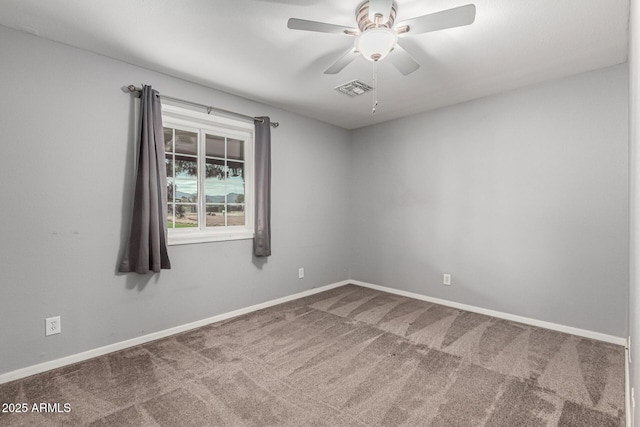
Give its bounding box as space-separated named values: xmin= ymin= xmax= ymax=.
xmin=0 ymin=27 xmax=350 ymax=373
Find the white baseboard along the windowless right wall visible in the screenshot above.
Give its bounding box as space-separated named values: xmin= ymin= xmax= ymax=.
xmin=349 ymin=280 xmax=627 ymax=347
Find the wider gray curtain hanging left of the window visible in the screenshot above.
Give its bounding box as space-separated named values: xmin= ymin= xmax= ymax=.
xmin=120 ymin=86 xmax=171 ymax=274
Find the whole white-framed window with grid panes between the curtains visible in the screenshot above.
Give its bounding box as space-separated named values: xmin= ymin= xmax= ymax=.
xmin=162 ymin=105 xmax=254 ymax=245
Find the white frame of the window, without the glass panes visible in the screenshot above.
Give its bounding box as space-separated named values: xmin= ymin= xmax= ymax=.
xmin=162 ymin=103 xmax=255 ymax=246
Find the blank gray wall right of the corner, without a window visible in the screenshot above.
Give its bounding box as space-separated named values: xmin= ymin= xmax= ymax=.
xmin=350 ymin=65 xmax=629 ymax=337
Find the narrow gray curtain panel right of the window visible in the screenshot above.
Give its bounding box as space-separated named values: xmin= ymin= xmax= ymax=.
xmin=253 ymin=117 xmax=271 ymax=257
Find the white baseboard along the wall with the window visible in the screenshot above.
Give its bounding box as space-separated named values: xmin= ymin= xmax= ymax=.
xmin=0 ymin=280 xmax=351 ymax=384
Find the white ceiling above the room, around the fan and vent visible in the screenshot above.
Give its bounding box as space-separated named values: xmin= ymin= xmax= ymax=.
xmin=0 ymin=0 xmax=629 ymax=129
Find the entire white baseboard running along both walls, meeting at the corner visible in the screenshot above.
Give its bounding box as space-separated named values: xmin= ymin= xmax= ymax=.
xmin=0 ymin=280 xmax=627 ymax=384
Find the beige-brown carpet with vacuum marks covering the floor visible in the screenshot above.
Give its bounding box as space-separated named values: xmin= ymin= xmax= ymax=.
xmin=0 ymin=285 xmax=624 ymax=427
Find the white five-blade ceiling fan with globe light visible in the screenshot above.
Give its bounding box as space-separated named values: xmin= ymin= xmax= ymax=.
xmin=287 ymin=0 xmax=476 ymax=76
